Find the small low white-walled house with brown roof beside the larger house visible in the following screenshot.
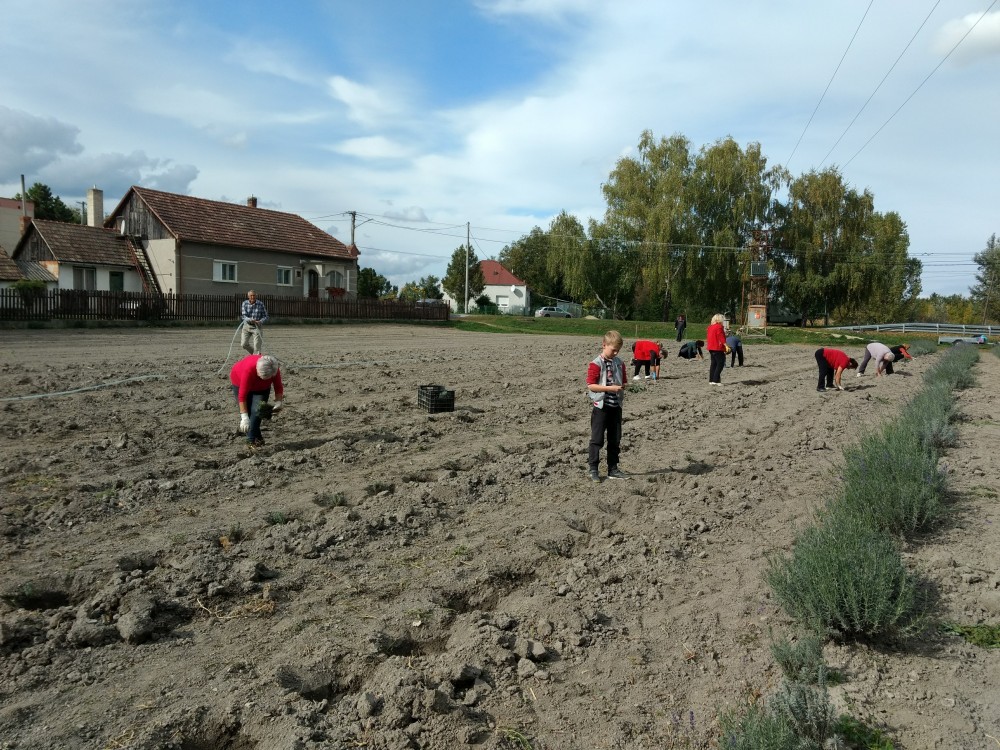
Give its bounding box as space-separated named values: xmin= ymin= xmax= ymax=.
xmin=13 ymin=219 xmax=155 ymax=292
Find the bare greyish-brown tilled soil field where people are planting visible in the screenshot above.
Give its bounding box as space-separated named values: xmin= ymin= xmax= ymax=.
xmin=0 ymin=325 xmax=1000 ymax=750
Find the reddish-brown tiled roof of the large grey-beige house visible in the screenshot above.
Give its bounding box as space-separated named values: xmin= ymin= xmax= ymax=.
xmin=122 ymin=186 xmax=357 ymax=260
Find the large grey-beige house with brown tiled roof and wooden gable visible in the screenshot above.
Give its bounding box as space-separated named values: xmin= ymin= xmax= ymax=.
xmin=105 ymin=186 xmax=358 ymax=298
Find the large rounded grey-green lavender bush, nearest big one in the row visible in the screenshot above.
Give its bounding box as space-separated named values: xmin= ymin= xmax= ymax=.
xmin=765 ymin=511 xmax=928 ymax=641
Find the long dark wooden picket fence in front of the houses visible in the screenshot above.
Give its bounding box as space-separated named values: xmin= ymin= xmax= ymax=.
xmin=0 ymin=289 xmax=450 ymax=323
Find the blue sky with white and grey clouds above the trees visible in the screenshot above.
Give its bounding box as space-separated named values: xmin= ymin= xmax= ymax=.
xmin=0 ymin=0 xmax=1000 ymax=296
